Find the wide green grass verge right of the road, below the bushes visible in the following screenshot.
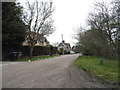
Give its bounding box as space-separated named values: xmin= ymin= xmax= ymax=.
xmin=74 ymin=56 xmax=120 ymax=85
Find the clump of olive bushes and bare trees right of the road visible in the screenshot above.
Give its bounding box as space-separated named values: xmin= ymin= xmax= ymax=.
xmin=76 ymin=0 xmax=120 ymax=58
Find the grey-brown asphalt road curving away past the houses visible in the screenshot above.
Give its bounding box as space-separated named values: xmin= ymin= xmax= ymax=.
xmin=0 ymin=54 xmax=104 ymax=88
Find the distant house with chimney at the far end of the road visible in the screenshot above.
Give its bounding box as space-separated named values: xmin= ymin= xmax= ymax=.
xmin=58 ymin=40 xmax=72 ymax=54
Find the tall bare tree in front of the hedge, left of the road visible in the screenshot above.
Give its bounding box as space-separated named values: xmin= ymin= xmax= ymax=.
xmin=23 ymin=0 xmax=54 ymax=57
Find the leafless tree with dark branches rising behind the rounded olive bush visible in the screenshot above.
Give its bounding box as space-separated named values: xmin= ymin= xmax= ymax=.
xmin=88 ymin=2 xmax=116 ymax=57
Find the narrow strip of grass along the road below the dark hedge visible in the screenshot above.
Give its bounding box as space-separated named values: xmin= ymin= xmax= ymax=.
xmin=6 ymin=55 xmax=59 ymax=62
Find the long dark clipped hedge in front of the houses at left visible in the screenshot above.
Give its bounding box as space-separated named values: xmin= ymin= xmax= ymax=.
xmin=2 ymin=46 xmax=57 ymax=60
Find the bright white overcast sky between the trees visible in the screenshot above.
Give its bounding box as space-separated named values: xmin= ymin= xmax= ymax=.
xmin=19 ymin=0 xmax=109 ymax=46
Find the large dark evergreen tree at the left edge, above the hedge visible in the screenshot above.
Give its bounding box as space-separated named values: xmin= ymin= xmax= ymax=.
xmin=2 ymin=2 xmax=25 ymax=49
